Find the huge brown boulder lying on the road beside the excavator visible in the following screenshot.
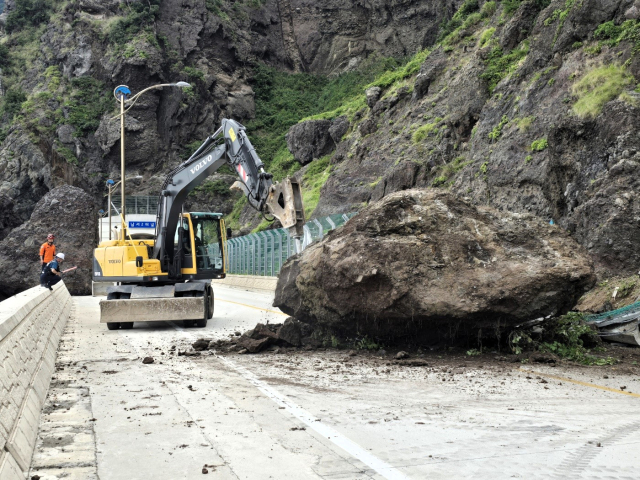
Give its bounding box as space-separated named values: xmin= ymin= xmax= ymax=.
xmin=274 ymin=190 xmax=595 ymax=340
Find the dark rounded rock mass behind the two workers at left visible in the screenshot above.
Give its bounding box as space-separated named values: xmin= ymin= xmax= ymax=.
xmin=0 ymin=185 xmax=98 ymax=297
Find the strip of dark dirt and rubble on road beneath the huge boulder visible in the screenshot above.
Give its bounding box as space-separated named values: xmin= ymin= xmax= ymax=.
xmin=167 ymin=327 xmax=640 ymax=393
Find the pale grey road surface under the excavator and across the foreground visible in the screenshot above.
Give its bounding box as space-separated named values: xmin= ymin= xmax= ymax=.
xmin=30 ymin=286 xmax=640 ymax=480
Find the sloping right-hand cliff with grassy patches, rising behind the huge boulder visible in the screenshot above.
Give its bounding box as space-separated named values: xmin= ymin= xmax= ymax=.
xmin=290 ymin=0 xmax=640 ymax=275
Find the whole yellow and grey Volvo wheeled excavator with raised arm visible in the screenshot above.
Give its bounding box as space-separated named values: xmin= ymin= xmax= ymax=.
xmin=93 ymin=119 xmax=305 ymax=330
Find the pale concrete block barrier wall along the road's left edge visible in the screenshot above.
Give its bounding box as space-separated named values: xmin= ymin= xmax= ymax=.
xmin=0 ymin=282 xmax=72 ymax=480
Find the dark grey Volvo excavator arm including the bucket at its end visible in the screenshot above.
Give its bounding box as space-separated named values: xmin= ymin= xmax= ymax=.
xmin=153 ymin=119 xmax=304 ymax=275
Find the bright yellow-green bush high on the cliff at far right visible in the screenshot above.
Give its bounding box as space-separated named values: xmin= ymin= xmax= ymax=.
xmin=571 ymin=65 xmax=635 ymax=118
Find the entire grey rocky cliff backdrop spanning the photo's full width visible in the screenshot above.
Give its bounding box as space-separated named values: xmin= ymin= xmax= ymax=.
xmin=0 ymin=0 xmax=640 ymax=296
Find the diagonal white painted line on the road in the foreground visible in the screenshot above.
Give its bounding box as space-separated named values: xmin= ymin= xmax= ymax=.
xmin=216 ymin=355 xmax=409 ymax=480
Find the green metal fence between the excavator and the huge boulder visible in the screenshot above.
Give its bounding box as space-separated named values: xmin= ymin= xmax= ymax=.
xmin=227 ymin=213 xmax=355 ymax=277
